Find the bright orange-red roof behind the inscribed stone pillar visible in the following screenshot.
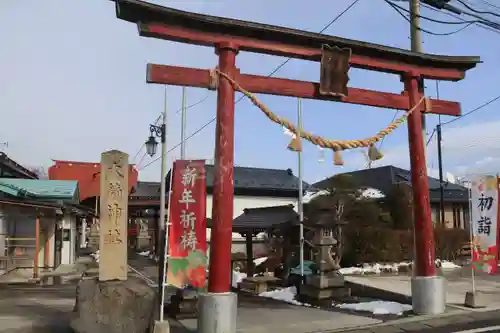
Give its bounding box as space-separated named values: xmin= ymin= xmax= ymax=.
xmin=49 ymin=160 xmax=139 ymax=201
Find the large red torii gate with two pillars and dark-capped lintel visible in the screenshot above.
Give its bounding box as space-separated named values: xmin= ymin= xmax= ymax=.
xmin=113 ymin=0 xmax=480 ymax=320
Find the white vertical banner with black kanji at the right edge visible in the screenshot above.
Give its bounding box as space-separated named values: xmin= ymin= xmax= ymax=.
xmin=471 ymin=176 xmax=498 ymax=274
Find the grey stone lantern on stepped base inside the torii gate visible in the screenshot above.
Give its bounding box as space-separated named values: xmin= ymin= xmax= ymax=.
xmin=300 ymin=204 xmax=351 ymax=301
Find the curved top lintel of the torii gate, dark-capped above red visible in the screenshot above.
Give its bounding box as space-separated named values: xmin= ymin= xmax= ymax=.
xmin=111 ymin=0 xmax=480 ymax=81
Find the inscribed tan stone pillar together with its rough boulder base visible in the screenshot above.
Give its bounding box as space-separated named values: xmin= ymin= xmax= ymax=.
xmin=71 ymin=150 xmax=156 ymax=333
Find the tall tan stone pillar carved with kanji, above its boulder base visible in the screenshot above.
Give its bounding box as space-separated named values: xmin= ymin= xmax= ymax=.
xmin=99 ymin=150 xmax=129 ymax=281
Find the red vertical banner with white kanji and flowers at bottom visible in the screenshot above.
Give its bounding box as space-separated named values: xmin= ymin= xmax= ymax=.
xmin=167 ymin=160 xmax=207 ymax=291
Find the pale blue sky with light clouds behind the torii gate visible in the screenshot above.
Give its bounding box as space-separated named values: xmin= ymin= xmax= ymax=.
xmin=0 ymin=0 xmax=500 ymax=182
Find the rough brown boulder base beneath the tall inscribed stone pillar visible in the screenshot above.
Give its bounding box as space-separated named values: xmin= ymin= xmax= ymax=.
xmin=71 ymin=277 xmax=157 ymax=333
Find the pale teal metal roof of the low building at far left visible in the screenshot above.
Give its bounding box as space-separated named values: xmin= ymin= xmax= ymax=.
xmin=0 ymin=178 xmax=80 ymax=203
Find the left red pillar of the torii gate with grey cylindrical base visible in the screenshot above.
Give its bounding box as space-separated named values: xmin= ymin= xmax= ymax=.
xmin=198 ymin=43 xmax=238 ymax=333
